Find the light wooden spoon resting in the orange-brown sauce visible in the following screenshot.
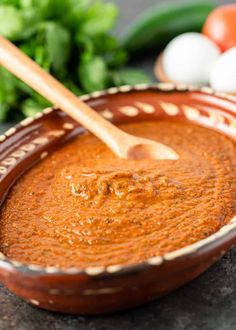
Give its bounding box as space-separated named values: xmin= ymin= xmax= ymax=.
xmin=0 ymin=36 xmax=178 ymax=160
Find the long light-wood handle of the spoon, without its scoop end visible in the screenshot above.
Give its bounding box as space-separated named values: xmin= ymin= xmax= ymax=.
xmin=0 ymin=36 xmax=126 ymax=156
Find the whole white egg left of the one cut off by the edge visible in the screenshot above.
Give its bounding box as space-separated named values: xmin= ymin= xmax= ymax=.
xmin=163 ymin=32 xmax=220 ymax=85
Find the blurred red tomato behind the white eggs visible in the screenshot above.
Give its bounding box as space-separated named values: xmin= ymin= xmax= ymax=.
xmin=202 ymin=4 xmax=236 ymax=51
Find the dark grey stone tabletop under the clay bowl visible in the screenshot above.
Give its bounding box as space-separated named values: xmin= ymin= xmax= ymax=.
xmin=0 ymin=0 xmax=236 ymax=330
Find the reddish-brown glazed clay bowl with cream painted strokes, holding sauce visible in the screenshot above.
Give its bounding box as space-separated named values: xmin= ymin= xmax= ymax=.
xmin=0 ymin=83 xmax=236 ymax=314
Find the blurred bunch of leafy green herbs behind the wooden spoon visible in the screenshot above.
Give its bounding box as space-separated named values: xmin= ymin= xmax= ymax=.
xmin=0 ymin=0 xmax=147 ymax=121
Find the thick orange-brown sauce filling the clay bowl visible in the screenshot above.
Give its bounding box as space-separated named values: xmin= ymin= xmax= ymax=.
xmin=0 ymin=121 xmax=236 ymax=268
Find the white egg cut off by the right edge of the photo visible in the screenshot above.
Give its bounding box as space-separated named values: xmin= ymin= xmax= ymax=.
xmin=210 ymin=47 xmax=236 ymax=93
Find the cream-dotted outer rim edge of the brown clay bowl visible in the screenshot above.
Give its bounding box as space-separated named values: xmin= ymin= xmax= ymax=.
xmin=0 ymin=82 xmax=236 ymax=277
